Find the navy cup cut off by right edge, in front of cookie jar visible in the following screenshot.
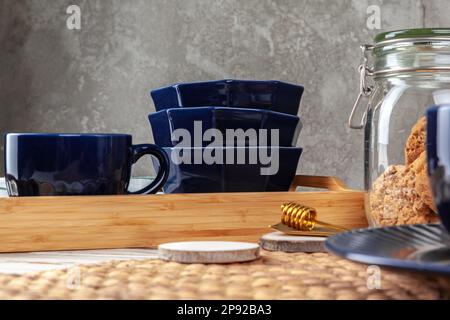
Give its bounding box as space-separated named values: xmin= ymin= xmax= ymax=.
xmin=427 ymin=105 xmax=450 ymax=232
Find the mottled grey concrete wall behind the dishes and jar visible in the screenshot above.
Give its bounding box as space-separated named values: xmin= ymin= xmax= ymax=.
xmin=0 ymin=0 xmax=450 ymax=187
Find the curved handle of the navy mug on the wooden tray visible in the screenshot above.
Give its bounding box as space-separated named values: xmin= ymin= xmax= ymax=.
xmin=127 ymin=144 xmax=169 ymax=194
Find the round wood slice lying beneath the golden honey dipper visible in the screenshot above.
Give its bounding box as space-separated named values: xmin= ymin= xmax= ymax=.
xmin=259 ymin=232 xmax=327 ymax=252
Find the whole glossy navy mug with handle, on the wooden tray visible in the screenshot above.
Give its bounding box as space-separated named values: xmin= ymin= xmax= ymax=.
xmin=5 ymin=133 xmax=169 ymax=196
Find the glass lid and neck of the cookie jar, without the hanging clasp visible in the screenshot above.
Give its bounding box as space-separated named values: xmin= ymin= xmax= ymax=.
xmin=367 ymin=28 xmax=450 ymax=78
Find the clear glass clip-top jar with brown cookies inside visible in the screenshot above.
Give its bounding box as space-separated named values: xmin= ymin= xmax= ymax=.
xmin=349 ymin=29 xmax=450 ymax=226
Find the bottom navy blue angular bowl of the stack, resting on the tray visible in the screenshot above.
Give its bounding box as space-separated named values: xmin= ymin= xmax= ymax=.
xmin=154 ymin=147 xmax=302 ymax=193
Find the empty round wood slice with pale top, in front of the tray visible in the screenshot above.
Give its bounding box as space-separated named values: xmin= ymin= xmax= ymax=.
xmin=158 ymin=241 xmax=259 ymax=263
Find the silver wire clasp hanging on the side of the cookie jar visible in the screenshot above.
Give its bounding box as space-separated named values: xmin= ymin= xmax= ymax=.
xmin=348 ymin=44 xmax=374 ymax=129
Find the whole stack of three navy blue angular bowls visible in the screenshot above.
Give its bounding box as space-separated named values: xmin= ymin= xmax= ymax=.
xmin=149 ymin=80 xmax=303 ymax=193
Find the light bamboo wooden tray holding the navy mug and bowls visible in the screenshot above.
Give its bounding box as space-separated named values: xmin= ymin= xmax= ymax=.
xmin=0 ymin=176 xmax=367 ymax=252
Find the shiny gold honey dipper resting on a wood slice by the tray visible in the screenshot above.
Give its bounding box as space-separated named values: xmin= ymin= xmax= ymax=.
xmin=270 ymin=202 xmax=348 ymax=236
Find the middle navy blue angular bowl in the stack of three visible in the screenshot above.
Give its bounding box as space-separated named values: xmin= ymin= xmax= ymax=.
xmin=148 ymin=107 xmax=302 ymax=147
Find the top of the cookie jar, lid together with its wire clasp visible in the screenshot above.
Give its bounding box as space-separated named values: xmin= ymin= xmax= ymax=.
xmin=348 ymin=28 xmax=450 ymax=129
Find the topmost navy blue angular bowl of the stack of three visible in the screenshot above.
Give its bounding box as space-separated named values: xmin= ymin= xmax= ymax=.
xmin=151 ymin=80 xmax=304 ymax=115
